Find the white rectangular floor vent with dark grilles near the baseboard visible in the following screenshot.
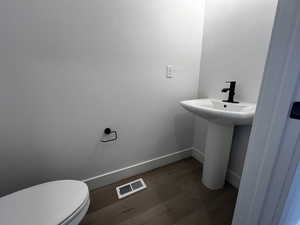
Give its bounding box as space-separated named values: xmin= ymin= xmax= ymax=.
xmin=116 ymin=178 xmax=147 ymax=199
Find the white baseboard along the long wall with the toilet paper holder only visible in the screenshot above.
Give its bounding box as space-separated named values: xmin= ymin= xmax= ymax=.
xmin=83 ymin=148 xmax=193 ymax=190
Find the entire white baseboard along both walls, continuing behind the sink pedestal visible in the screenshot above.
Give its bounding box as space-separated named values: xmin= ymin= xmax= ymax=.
xmin=83 ymin=148 xmax=240 ymax=190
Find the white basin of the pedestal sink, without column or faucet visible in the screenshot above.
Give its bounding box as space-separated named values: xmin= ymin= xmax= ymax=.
xmin=180 ymin=99 xmax=256 ymax=125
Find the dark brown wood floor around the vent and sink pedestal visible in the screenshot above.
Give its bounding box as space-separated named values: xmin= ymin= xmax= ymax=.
xmin=80 ymin=158 xmax=237 ymax=225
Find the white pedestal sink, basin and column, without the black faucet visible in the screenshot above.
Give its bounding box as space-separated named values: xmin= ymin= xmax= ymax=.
xmin=180 ymin=99 xmax=256 ymax=190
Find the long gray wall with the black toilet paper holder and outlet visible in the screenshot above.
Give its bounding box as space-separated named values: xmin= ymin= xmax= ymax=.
xmin=0 ymin=0 xmax=204 ymax=195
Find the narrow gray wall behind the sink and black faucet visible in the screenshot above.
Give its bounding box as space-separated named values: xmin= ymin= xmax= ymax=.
xmin=194 ymin=0 xmax=277 ymax=175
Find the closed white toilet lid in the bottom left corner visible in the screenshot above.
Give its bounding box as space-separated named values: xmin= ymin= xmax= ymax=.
xmin=0 ymin=180 xmax=89 ymax=225
